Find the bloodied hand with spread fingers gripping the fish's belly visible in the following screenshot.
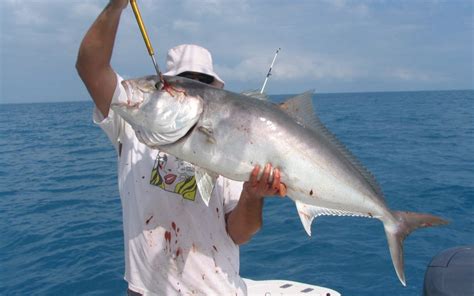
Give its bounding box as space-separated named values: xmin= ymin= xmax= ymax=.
xmin=243 ymin=164 xmax=286 ymax=198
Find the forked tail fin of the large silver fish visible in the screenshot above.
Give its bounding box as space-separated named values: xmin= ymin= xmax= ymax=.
xmin=384 ymin=212 xmax=448 ymax=286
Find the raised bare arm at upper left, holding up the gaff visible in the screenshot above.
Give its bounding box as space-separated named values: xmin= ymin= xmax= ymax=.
xmin=76 ymin=0 xmax=128 ymax=117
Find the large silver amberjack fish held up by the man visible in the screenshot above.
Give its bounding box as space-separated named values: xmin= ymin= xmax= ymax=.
xmin=111 ymin=76 xmax=447 ymax=285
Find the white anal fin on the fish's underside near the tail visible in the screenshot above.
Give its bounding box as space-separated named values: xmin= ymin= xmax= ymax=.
xmin=295 ymin=200 xmax=372 ymax=236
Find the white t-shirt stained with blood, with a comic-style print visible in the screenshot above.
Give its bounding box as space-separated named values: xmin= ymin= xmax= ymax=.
xmin=93 ymin=75 xmax=247 ymax=295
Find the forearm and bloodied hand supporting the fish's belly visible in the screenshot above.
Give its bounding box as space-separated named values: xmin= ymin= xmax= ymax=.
xmin=226 ymin=164 xmax=286 ymax=245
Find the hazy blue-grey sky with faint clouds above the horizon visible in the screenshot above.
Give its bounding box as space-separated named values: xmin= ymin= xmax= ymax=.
xmin=0 ymin=0 xmax=474 ymax=103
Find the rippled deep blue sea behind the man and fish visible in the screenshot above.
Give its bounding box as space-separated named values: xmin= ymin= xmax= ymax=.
xmin=0 ymin=91 xmax=474 ymax=295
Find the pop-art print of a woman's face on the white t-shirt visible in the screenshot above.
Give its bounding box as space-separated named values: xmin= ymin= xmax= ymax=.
xmin=150 ymin=151 xmax=197 ymax=201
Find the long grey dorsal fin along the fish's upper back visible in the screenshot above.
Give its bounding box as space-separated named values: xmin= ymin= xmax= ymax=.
xmin=280 ymin=91 xmax=384 ymax=200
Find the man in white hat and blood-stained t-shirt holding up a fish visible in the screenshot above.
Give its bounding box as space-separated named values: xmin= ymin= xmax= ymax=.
xmin=76 ymin=0 xmax=286 ymax=295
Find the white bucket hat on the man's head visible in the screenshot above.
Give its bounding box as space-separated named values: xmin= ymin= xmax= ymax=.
xmin=163 ymin=44 xmax=224 ymax=88
